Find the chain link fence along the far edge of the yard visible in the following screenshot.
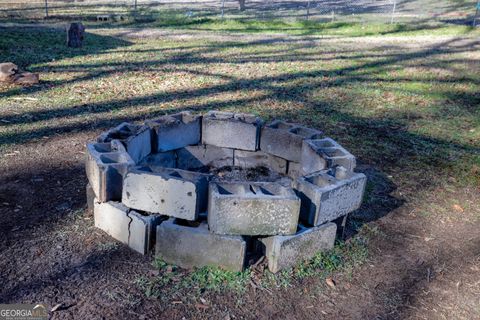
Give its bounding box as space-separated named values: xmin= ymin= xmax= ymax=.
xmin=0 ymin=0 xmax=480 ymax=24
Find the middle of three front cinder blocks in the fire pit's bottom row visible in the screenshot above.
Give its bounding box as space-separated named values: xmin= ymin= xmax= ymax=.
xmin=155 ymin=219 xmax=246 ymax=271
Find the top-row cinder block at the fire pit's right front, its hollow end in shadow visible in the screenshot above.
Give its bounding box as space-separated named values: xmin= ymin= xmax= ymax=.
xmin=294 ymin=167 xmax=367 ymax=226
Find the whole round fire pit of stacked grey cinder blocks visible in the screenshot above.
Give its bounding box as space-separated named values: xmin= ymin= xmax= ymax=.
xmin=86 ymin=111 xmax=366 ymax=272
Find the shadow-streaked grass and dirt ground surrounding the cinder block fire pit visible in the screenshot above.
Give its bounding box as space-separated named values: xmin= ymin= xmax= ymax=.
xmin=0 ymin=28 xmax=480 ymax=319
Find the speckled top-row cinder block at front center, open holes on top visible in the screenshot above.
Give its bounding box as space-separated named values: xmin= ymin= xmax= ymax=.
xmin=208 ymin=182 xmax=300 ymax=235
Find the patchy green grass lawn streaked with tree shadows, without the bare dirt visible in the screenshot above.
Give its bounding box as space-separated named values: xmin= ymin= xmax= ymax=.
xmin=0 ymin=19 xmax=480 ymax=319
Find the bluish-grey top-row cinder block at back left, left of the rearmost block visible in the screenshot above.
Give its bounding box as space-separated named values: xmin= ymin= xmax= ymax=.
xmin=145 ymin=112 xmax=202 ymax=152
